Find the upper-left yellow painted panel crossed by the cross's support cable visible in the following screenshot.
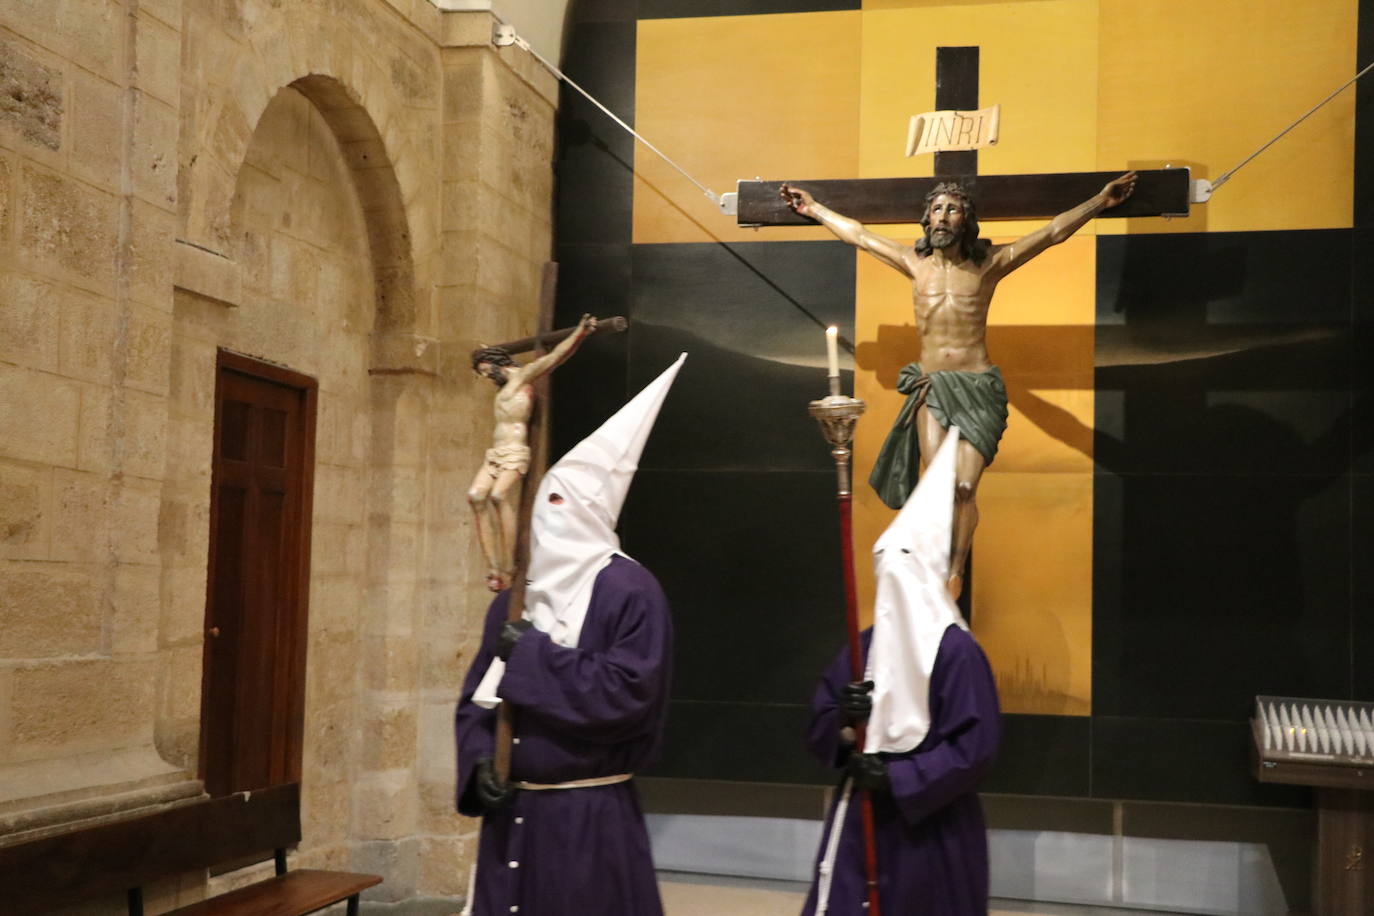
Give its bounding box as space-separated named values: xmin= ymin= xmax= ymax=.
xmin=633 ymin=10 xmax=863 ymax=243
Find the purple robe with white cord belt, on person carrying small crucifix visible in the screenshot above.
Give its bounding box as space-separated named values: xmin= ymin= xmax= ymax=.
xmin=456 ymin=556 xmax=672 ymax=916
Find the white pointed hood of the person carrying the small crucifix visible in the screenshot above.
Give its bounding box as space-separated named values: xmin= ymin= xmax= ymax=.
xmin=473 ymin=353 xmax=687 ymax=709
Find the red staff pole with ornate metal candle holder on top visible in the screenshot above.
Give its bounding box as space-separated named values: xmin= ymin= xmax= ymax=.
xmin=811 ymin=374 xmax=879 ymax=916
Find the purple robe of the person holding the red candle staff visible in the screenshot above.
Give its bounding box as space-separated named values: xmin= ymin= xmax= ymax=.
xmin=802 ymin=625 xmax=1002 ymax=916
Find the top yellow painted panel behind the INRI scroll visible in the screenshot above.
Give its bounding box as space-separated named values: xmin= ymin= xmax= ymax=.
xmin=859 ymin=0 xmax=1098 ymax=189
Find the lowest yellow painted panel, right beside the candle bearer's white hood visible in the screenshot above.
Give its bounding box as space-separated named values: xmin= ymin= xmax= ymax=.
xmin=973 ymin=474 xmax=1092 ymax=715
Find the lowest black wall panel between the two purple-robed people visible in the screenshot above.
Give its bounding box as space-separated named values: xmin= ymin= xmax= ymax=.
xmin=646 ymin=700 xmax=840 ymax=786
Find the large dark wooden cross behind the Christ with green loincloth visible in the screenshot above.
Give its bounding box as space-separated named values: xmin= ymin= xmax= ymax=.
xmin=735 ymin=47 xmax=1190 ymax=227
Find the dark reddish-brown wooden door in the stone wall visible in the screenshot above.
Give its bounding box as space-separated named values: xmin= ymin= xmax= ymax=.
xmin=201 ymin=350 xmax=316 ymax=795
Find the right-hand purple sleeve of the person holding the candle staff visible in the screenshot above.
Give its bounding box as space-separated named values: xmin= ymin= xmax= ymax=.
xmin=888 ymin=628 xmax=1002 ymax=824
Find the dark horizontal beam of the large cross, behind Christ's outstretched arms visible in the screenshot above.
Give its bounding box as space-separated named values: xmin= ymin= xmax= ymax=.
xmin=736 ymin=169 xmax=1190 ymax=227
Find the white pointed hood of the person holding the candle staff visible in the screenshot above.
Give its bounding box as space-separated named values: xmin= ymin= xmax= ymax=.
xmin=864 ymin=427 xmax=969 ymax=754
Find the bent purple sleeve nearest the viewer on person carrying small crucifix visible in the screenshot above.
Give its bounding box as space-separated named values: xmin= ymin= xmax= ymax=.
xmin=496 ymin=569 xmax=672 ymax=744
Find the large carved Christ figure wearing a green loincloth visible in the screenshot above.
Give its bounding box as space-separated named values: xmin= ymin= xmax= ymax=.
xmin=780 ymin=172 xmax=1136 ymax=597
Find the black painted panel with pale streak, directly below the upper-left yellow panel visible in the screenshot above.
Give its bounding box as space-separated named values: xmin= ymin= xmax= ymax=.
xmin=631 ymin=242 xmax=853 ymax=470
